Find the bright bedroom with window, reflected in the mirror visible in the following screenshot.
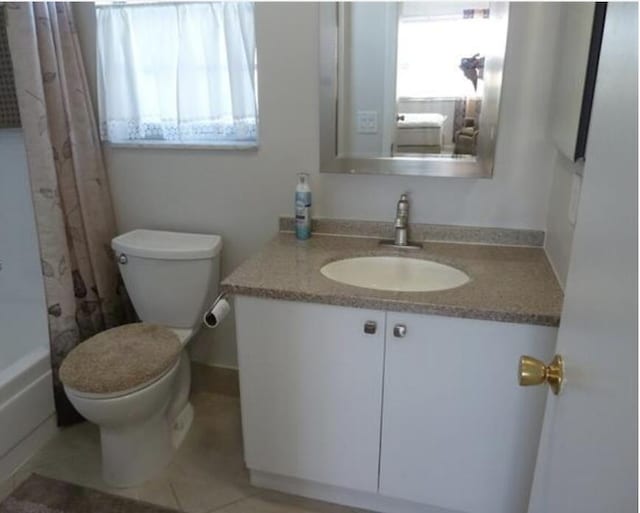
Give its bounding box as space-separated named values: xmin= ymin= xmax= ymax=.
xmin=392 ymin=2 xmax=491 ymax=156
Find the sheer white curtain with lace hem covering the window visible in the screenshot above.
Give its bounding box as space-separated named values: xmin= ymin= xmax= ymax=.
xmin=97 ymin=2 xmax=257 ymax=143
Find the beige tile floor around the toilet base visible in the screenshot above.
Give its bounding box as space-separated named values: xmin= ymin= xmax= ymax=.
xmin=0 ymin=366 xmax=358 ymax=513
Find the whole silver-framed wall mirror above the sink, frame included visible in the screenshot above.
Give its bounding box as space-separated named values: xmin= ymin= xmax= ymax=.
xmin=320 ymin=1 xmax=509 ymax=177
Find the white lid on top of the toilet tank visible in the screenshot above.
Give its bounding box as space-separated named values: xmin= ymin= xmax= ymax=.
xmin=111 ymin=230 xmax=222 ymax=260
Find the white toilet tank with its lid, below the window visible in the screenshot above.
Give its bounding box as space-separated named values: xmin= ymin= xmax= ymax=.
xmin=111 ymin=230 xmax=222 ymax=328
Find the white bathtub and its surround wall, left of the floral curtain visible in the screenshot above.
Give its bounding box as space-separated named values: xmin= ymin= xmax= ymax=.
xmin=0 ymin=130 xmax=56 ymax=481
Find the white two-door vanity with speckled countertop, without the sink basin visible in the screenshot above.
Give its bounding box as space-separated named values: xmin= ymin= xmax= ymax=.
xmin=223 ymin=222 xmax=562 ymax=513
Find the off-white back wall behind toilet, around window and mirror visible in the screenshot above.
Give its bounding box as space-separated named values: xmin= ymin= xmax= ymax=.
xmin=76 ymin=3 xmax=556 ymax=366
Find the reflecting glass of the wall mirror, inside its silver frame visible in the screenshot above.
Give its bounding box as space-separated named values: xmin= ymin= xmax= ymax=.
xmin=337 ymin=2 xmax=504 ymax=160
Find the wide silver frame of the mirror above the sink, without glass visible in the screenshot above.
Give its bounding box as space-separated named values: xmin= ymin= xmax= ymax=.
xmin=319 ymin=2 xmax=509 ymax=178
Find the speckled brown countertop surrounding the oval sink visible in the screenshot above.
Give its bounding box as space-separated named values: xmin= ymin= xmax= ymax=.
xmin=222 ymin=232 xmax=563 ymax=326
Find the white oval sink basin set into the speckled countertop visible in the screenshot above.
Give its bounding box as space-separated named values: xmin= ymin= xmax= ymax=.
xmin=320 ymin=256 xmax=470 ymax=292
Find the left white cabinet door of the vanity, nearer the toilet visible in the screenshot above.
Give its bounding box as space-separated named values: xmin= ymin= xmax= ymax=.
xmin=235 ymin=296 xmax=385 ymax=492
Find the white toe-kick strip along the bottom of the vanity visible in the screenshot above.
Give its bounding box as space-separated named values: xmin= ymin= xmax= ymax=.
xmin=249 ymin=470 xmax=461 ymax=513
